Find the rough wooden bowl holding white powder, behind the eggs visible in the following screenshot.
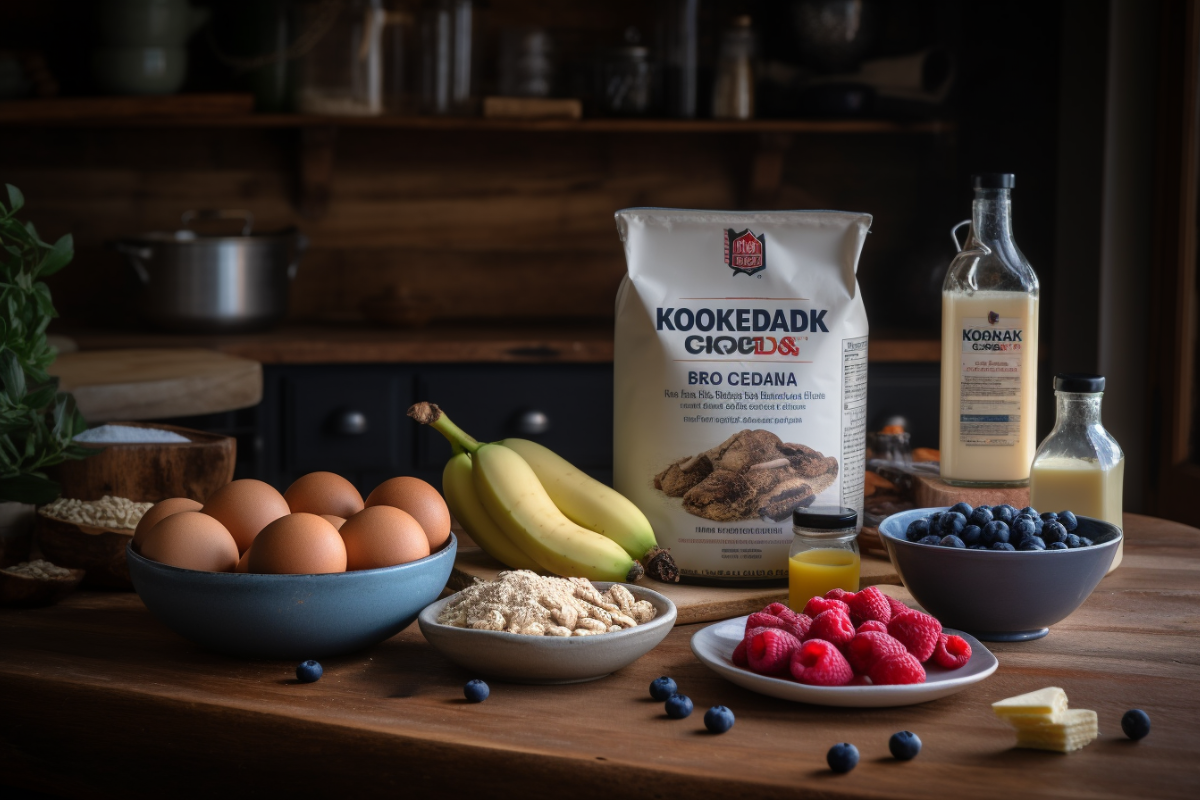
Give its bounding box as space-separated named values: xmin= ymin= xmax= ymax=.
xmin=52 ymin=422 xmax=238 ymax=501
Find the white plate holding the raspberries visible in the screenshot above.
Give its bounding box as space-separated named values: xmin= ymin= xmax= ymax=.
xmin=691 ymin=616 xmax=1000 ymax=708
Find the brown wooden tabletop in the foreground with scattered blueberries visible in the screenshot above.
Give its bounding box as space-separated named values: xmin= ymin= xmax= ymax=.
xmin=0 ymin=515 xmax=1200 ymax=800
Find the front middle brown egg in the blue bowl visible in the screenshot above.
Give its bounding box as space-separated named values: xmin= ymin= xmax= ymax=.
xmin=246 ymin=511 xmax=346 ymax=575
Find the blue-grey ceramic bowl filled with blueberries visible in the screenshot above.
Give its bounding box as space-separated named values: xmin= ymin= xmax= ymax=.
xmin=880 ymin=509 xmax=1122 ymax=642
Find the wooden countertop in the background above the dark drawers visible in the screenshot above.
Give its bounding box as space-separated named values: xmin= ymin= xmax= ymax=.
xmin=55 ymin=323 xmax=941 ymax=363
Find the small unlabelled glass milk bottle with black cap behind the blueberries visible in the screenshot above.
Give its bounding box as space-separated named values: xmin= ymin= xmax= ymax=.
xmin=1030 ymin=373 xmax=1124 ymax=572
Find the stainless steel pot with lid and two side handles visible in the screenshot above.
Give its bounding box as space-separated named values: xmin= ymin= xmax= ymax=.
xmin=112 ymin=210 xmax=308 ymax=332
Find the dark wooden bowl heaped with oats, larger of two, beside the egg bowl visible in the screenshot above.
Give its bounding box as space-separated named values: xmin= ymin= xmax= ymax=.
xmin=34 ymin=513 xmax=133 ymax=589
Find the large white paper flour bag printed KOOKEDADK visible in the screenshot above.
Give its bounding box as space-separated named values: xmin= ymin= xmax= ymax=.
xmin=613 ymin=209 xmax=871 ymax=582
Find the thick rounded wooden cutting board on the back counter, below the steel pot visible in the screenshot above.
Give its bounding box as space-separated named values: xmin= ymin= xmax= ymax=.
xmin=49 ymin=348 xmax=263 ymax=422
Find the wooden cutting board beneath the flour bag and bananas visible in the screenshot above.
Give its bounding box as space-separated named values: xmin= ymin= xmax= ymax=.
xmin=446 ymin=544 xmax=900 ymax=625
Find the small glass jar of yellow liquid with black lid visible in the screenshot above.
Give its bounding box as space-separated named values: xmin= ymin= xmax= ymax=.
xmin=787 ymin=506 xmax=859 ymax=613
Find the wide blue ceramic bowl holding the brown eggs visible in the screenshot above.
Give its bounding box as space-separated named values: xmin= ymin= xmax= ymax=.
xmin=125 ymin=534 xmax=458 ymax=660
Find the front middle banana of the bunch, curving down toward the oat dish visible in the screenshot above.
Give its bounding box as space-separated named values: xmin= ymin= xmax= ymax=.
xmin=472 ymin=445 xmax=643 ymax=581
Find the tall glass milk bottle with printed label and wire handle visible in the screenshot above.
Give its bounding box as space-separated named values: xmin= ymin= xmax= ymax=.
xmin=941 ymin=174 xmax=1038 ymax=486
